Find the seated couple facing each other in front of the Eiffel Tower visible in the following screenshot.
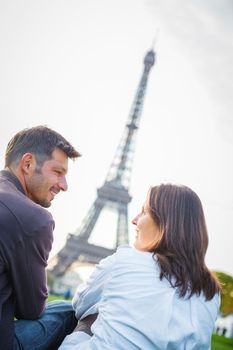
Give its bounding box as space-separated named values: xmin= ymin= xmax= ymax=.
xmin=0 ymin=126 xmax=220 ymax=350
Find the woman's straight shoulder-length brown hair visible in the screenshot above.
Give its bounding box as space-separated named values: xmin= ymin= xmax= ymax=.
xmin=149 ymin=184 xmax=221 ymax=300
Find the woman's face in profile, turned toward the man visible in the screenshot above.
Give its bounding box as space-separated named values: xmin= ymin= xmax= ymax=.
xmin=132 ymin=194 xmax=160 ymax=252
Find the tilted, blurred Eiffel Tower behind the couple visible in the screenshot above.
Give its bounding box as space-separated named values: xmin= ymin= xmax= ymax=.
xmin=51 ymin=48 xmax=155 ymax=277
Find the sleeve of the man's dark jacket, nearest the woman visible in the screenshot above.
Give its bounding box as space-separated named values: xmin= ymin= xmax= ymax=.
xmin=11 ymin=220 xmax=54 ymax=319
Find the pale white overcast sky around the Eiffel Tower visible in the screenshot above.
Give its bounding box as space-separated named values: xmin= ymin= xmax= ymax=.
xmin=0 ymin=0 xmax=233 ymax=274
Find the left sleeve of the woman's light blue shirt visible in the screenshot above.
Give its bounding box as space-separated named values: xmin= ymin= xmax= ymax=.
xmin=72 ymin=254 xmax=116 ymax=319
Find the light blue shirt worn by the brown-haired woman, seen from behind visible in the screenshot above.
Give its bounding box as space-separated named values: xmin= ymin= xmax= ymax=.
xmin=59 ymin=246 xmax=219 ymax=350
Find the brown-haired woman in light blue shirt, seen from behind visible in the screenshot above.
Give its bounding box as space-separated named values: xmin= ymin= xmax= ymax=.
xmin=59 ymin=184 xmax=220 ymax=350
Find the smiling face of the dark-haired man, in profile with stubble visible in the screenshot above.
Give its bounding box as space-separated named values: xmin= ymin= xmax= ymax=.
xmin=25 ymin=148 xmax=68 ymax=208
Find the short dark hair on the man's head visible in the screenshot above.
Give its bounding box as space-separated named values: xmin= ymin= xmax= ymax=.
xmin=5 ymin=125 xmax=80 ymax=168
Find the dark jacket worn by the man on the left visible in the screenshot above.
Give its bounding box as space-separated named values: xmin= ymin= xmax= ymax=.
xmin=0 ymin=170 xmax=54 ymax=350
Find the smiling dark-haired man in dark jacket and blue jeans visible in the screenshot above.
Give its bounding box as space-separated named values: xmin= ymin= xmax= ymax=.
xmin=0 ymin=126 xmax=80 ymax=350
